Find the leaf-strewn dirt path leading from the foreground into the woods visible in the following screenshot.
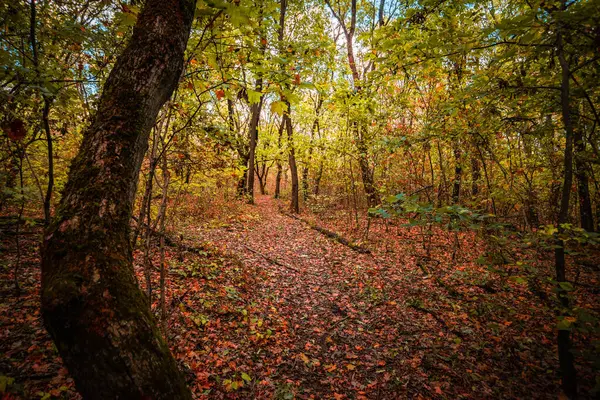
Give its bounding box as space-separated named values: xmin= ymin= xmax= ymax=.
xmin=190 ymin=196 xmax=458 ymax=398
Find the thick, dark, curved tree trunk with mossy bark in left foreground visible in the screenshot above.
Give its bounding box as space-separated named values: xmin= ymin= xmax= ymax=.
xmin=42 ymin=0 xmax=195 ymax=399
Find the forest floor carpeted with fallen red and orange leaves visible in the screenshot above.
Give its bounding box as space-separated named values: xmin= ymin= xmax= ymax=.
xmin=0 ymin=196 xmax=598 ymax=399
